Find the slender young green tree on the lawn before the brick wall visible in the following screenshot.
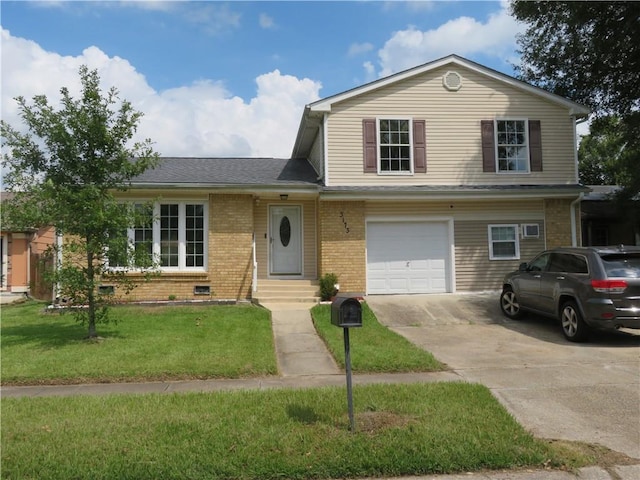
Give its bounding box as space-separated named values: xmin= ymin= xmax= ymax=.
xmin=0 ymin=66 xmax=158 ymax=338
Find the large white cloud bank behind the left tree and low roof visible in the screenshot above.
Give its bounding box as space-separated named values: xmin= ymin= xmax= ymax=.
xmin=1 ymin=29 xmax=321 ymax=157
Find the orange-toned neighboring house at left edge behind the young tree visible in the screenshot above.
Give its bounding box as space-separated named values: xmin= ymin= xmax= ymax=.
xmin=0 ymin=192 xmax=55 ymax=300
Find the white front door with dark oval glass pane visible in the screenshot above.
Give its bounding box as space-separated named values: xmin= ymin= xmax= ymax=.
xmin=269 ymin=205 xmax=302 ymax=275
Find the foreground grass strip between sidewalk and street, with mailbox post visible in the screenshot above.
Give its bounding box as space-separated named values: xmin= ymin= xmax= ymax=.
xmin=2 ymin=383 xmax=586 ymax=480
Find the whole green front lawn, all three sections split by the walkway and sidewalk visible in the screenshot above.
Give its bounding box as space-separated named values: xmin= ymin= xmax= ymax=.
xmin=1 ymin=303 xmax=593 ymax=480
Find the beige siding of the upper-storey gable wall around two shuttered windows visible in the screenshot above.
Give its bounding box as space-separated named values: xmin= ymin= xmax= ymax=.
xmin=327 ymin=67 xmax=576 ymax=186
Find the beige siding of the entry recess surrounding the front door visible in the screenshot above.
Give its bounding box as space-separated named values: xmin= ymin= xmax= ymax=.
xmin=254 ymin=198 xmax=318 ymax=279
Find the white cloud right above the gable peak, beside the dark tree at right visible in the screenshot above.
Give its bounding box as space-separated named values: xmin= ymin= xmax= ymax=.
xmin=378 ymin=2 xmax=522 ymax=77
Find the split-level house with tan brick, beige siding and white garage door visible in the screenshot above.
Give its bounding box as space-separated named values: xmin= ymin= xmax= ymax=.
xmin=105 ymin=55 xmax=589 ymax=300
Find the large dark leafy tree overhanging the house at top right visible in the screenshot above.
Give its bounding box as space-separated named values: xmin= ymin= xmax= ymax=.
xmin=511 ymin=0 xmax=640 ymax=198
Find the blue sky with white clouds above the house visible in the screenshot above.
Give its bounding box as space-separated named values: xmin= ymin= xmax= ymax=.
xmin=0 ymin=0 xmax=536 ymax=158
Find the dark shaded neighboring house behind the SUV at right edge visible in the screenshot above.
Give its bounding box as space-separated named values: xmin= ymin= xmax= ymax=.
xmin=580 ymin=185 xmax=640 ymax=246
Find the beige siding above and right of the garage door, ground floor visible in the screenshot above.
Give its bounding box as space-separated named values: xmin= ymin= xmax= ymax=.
xmin=365 ymin=199 xmax=545 ymax=292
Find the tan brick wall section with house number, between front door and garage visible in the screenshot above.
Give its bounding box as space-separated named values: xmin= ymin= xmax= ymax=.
xmin=318 ymin=201 xmax=367 ymax=292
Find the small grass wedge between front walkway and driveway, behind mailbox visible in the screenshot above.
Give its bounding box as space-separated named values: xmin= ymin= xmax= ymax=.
xmin=311 ymin=303 xmax=445 ymax=373
